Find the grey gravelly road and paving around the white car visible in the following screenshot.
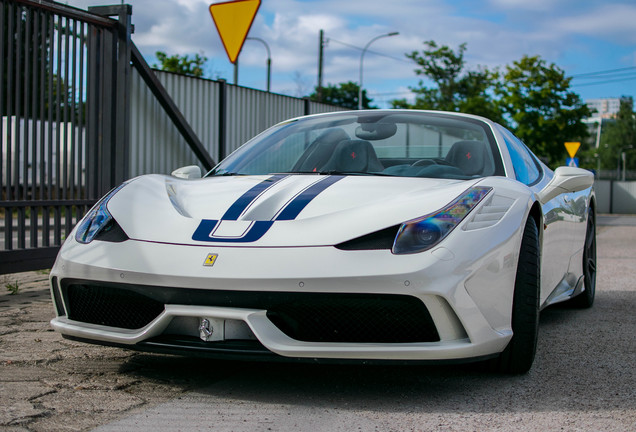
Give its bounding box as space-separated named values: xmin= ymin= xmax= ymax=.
xmin=0 ymin=226 xmax=636 ymax=432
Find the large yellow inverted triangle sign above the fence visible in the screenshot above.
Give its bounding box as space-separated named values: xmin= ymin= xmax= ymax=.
xmin=210 ymin=0 xmax=261 ymax=63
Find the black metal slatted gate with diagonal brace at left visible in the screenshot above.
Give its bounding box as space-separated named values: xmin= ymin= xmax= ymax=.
xmin=0 ymin=0 xmax=213 ymax=274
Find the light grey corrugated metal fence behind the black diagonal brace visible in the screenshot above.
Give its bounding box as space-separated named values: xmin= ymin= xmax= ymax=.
xmin=130 ymin=70 xmax=344 ymax=176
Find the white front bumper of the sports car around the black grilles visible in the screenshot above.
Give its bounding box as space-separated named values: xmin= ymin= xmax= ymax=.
xmin=51 ymin=223 xmax=518 ymax=361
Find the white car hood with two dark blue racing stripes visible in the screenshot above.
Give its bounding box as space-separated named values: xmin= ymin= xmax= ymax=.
xmin=108 ymin=175 xmax=479 ymax=247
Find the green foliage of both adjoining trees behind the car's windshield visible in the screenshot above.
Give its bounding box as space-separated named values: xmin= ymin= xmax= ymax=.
xmin=392 ymin=41 xmax=590 ymax=166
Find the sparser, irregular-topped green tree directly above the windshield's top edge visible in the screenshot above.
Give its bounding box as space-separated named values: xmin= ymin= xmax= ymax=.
xmin=392 ymin=41 xmax=505 ymax=123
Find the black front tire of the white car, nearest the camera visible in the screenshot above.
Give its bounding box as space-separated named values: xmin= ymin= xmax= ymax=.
xmin=491 ymin=217 xmax=541 ymax=374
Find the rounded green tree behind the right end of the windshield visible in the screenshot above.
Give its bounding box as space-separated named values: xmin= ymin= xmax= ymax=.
xmin=496 ymin=56 xmax=590 ymax=166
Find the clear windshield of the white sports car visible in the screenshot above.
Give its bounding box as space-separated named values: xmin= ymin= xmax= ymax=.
xmin=208 ymin=111 xmax=503 ymax=179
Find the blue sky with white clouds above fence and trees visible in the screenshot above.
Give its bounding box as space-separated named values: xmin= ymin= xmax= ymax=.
xmin=63 ymin=0 xmax=636 ymax=108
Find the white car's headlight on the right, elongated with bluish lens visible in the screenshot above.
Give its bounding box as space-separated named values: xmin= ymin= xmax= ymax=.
xmin=392 ymin=187 xmax=492 ymax=255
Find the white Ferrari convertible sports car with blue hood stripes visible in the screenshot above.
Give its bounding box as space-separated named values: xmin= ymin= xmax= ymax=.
xmin=51 ymin=110 xmax=596 ymax=373
